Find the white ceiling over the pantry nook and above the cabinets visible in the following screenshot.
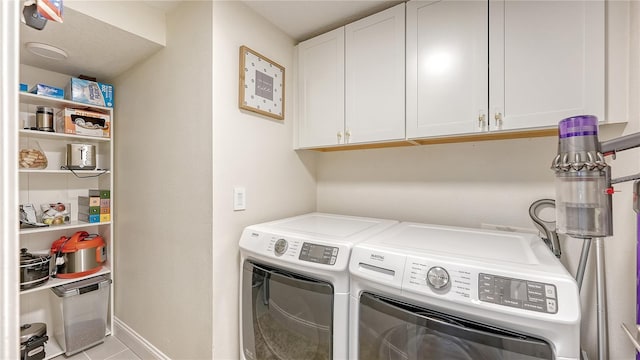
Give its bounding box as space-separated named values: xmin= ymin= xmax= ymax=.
xmin=20 ymin=0 xmax=402 ymax=82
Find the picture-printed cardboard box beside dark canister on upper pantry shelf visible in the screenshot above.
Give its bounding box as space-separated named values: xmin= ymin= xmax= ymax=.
xmin=56 ymin=108 xmax=111 ymax=137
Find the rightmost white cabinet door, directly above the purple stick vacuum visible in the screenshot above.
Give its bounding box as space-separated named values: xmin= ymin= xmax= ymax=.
xmin=489 ymin=0 xmax=605 ymax=130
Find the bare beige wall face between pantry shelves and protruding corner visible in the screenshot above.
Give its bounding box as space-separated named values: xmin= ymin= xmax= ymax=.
xmin=113 ymin=1 xmax=214 ymax=359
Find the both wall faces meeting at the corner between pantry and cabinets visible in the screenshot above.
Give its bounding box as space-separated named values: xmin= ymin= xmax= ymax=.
xmin=114 ymin=1 xmax=316 ymax=359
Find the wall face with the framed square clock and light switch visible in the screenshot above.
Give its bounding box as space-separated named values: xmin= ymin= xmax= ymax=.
xmin=213 ymin=1 xmax=316 ymax=360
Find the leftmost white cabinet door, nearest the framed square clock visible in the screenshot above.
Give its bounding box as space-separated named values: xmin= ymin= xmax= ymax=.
xmin=298 ymin=28 xmax=344 ymax=148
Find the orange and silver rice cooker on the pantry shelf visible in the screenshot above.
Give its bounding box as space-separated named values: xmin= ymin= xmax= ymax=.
xmin=51 ymin=231 xmax=107 ymax=279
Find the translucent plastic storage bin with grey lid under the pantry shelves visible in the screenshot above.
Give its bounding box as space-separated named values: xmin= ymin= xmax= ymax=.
xmin=51 ymin=275 xmax=111 ymax=356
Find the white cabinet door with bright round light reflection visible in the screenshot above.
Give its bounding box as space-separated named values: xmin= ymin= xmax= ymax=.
xmin=407 ymin=0 xmax=488 ymax=138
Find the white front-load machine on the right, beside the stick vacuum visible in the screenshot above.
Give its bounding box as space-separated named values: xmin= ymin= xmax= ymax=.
xmin=349 ymin=223 xmax=580 ymax=360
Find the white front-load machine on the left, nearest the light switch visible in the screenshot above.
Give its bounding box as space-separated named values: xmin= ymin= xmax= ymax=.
xmin=240 ymin=213 xmax=397 ymax=360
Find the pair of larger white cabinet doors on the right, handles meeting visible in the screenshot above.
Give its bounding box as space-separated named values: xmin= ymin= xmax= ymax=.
xmin=407 ymin=0 xmax=605 ymax=138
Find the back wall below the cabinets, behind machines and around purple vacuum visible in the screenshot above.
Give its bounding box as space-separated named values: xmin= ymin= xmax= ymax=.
xmin=317 ymin=1 xmax=640 ymax=360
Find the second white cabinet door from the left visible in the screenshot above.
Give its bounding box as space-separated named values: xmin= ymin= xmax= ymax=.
xmin=345 ymin=4 xmax=405 ymax=143
